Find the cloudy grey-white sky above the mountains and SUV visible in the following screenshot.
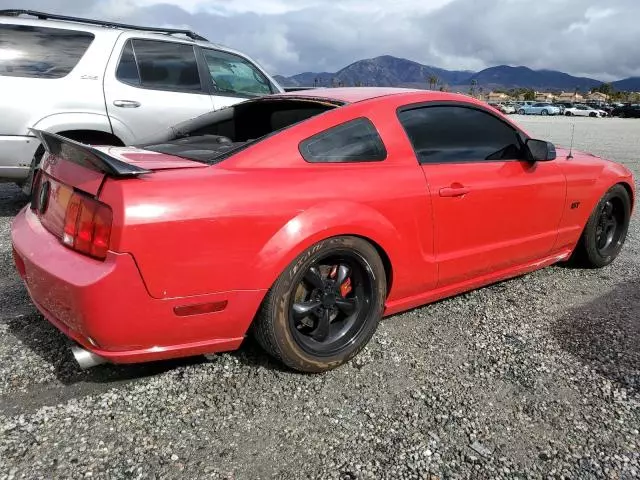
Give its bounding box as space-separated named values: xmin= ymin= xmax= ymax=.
xmin=0 ymin=0 xmax=640 ymax=81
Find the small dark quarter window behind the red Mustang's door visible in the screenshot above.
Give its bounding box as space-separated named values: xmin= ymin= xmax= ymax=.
xmin=300 ymin=118 xmax=387 ymax=163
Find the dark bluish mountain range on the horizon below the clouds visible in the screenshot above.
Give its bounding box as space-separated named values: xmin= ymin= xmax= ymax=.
xmin=276 ymin=55 xmax=616 ymax=92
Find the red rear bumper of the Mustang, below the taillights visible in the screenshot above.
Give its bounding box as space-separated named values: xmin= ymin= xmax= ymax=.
xmin=11 ymin=207 xmax=265 ymax=363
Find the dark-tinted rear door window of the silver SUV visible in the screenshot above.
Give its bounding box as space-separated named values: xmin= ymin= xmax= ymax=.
xmin=116 ymin=39 xmax=202 ymax=93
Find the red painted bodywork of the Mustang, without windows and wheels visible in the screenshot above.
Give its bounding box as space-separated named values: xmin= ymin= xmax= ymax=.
xmin=12 ymin=88 xmax=634 ymax=362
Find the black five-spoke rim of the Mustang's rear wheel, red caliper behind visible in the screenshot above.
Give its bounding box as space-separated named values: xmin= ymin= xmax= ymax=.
xmin=289 ymin=252 xmax=374 ymax=356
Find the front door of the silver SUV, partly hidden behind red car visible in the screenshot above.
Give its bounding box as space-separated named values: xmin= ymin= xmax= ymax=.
xmin=200 ymin=47 xmax=278 ymax=109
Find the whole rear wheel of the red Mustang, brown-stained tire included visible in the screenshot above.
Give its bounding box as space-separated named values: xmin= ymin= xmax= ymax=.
xmin=252 ymin=236 xmax=386 ymax=373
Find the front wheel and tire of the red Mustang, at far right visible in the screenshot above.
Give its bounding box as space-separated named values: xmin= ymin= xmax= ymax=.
xmin=572 ymin=185 xmax=631 ymax=268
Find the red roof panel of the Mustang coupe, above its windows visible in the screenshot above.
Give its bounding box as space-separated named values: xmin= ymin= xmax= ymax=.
xmin=269 ymin=87 xmax=477 ymax=103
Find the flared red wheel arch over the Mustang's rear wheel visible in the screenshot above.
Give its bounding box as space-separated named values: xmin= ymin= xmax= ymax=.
xmin=256 ymin=201 xmax=402 ymax=294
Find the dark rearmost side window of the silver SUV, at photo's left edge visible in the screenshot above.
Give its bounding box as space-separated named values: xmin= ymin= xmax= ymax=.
xmin=0 ymin=24 xmax=94 ymax=78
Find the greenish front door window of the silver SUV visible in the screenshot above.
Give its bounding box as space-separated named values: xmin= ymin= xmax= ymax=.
xmin=202 ymin=48 xmax=273 ymax=97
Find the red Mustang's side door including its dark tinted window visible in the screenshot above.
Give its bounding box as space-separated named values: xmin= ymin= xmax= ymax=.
xmin=398 ymin=103 xmax=566 ymax=287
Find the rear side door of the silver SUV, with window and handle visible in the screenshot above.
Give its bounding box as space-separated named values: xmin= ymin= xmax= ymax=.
xmin=104 ymin=38 xmax=213 ymax=143
